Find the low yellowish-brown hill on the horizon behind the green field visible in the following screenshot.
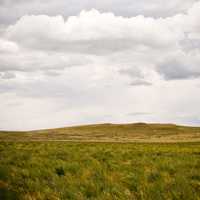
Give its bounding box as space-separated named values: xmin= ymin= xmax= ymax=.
xmin=0 ymin=123 xmax=200 ymax=142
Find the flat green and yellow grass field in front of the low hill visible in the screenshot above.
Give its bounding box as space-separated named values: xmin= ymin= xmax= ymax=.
xmin=0 ymin=142 xmax=200 ymax=200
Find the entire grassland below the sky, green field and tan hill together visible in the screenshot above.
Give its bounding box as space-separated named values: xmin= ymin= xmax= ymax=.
xmin=0 ymin=123 xmax=200 ymax=200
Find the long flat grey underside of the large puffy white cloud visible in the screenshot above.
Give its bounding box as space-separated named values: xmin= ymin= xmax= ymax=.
xmin=11 ymin=39 xmax=144 ymax=55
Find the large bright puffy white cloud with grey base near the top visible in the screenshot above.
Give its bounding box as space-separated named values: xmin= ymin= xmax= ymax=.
xmin=7 ymin=9 xmax=181 ymax=54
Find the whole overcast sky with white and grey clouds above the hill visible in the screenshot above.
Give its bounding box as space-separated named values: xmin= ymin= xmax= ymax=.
xmin=0 ymin=0 xmax=200 ymax=130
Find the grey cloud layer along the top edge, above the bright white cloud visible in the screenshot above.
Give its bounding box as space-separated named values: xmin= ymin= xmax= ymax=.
xmin=0 ymin=0 xmax=196 ymax=24
